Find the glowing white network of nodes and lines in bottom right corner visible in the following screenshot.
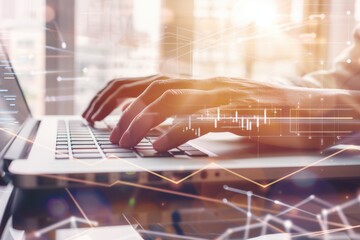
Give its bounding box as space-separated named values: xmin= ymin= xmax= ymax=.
xmin=217 ymin=185 xmax=360 ymax=240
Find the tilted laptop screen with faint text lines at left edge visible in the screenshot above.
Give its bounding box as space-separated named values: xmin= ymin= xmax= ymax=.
xmin=0 ymin=42 xmax=31 ymax=152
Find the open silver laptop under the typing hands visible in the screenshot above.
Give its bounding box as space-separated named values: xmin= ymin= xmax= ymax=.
xmin=0 ymin=41 xmax=360 ymax=189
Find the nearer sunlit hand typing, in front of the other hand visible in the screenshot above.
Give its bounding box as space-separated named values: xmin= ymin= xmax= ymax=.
xmin=105 ymin=78 xmax=292 ymax=151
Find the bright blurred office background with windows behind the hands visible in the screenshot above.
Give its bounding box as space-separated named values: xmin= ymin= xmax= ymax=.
xmin=0 ymin=0 xmax=360 ymax=115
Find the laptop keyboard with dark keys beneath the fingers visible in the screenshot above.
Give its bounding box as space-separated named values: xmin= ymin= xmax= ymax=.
xmin=55 ymin=120 xmax=208 ymax=160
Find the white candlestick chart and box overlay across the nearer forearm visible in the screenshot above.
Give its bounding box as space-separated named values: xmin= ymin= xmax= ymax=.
xmin=183 ymin=107 xmax=356 ymax=139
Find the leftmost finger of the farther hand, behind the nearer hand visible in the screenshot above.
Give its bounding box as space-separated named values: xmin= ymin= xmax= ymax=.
xmin=86 ymin=75 xmax=162 ymax=122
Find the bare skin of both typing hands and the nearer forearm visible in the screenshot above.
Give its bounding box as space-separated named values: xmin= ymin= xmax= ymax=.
xmin=82 ymin=75 xmax=360 ymax=151
